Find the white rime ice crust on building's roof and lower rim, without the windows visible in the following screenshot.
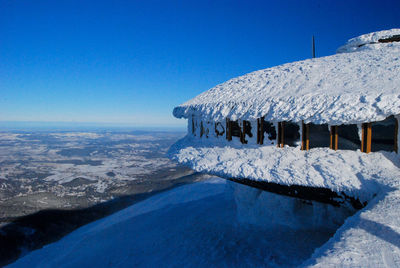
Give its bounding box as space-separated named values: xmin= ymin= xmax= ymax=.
xmin=169 ymin=29 xmax=400 ymax=201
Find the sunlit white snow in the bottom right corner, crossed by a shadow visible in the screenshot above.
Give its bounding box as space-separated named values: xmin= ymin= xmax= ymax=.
xmin=301 ymin=188 xmax=400 ymax=268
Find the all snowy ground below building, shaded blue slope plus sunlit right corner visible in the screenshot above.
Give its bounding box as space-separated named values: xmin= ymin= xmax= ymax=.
xmin=9 ymin=179 xmax=400 ymax=267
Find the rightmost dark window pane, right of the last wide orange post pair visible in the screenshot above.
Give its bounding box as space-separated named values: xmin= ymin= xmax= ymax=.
xmin=371 ymin=116 xmax=396 ymax=152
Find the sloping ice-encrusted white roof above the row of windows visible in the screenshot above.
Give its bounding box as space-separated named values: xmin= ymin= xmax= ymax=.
xmin=174 ymin=29 xmax=400 ymax=124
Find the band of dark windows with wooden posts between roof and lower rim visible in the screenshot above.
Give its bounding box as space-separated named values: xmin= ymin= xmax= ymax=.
xmin=190 ymin=116 xmax=398 ymax=153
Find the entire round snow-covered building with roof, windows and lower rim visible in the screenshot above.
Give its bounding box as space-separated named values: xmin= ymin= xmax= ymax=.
xmin=170 ymin=29 xmax=400 ymax=207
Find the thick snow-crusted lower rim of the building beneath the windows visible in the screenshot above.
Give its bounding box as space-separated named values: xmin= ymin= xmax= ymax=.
xmin=169 ymin=135 xmax=400 ymax=202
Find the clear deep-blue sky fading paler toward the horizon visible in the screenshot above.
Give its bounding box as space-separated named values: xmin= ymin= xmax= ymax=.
xmin=0 ymin=0 xmax=400 ymax=125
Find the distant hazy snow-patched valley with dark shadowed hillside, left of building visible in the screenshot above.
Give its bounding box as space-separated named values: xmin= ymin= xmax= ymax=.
xmin=0 ymin=126 xmax=212 ymax=266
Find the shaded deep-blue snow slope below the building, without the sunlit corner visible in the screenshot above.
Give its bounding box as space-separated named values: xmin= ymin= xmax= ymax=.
xmin=10 ymin=179 xmax=338 ymax=267
